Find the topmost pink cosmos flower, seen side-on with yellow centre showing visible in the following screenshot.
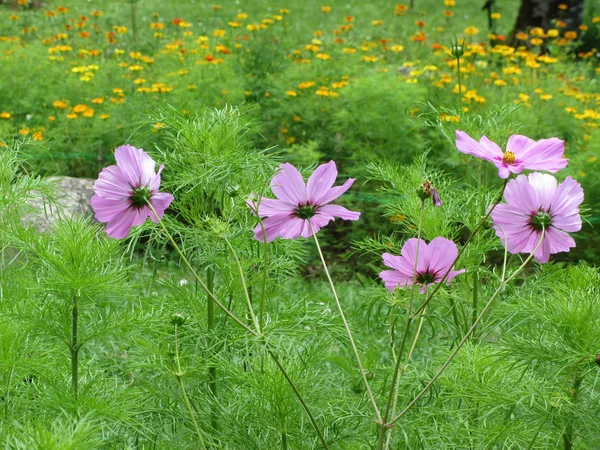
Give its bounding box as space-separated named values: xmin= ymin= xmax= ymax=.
xmin=456 ymin=130 xmax=568 ymax=178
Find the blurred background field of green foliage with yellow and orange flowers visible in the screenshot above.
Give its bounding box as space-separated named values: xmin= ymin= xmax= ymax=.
xmin=0 ymin=0 xmax=600 ymax=260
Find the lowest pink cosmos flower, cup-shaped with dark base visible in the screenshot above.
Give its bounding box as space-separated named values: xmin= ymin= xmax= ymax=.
xmin=379 ymin=237 xmax=465 ymax=294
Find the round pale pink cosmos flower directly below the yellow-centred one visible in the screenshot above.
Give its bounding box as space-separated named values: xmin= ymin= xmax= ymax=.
xmin=492 ymin=172 xmax=583 ymax=263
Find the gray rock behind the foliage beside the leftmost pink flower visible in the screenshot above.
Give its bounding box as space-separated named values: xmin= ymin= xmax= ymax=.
xmin=25 ymin=177 xmax=96 ymax=231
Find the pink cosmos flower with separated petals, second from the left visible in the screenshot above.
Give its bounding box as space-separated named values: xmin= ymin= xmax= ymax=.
xmin=248 ymin=161 xmax=360 ymax=242
